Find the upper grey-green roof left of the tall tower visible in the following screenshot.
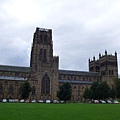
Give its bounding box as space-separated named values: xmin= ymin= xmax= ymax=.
xmin=0 ymin=65 xmax=32 ymax=73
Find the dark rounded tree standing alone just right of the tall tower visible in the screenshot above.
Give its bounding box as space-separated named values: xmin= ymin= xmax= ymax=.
xmin=57 ymin=82 xmax=72 ymax=102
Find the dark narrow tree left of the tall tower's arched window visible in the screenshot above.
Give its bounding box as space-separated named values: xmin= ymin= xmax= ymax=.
xmin=21 ymin=81 xmax=31 ymax=99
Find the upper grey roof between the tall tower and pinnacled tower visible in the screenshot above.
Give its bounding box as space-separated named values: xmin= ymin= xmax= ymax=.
xmin=59 ymin=70 xmax=100 ymax=77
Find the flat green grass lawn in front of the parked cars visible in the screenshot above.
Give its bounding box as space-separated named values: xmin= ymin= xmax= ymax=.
xmin=0 ymin=103 xmax=120 ymax=120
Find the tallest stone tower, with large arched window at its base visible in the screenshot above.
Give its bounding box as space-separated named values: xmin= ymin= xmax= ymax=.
xmin=30 ymin=28 xmax=59 ymax=100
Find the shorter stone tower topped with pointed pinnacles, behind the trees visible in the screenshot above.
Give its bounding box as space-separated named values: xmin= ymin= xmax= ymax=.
xmin=89 ymin=50 xmax=118 ymax=86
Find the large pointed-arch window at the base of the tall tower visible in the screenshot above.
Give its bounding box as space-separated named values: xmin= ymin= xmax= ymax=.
xmin=41 ymin=74 xmax=50 ymax=95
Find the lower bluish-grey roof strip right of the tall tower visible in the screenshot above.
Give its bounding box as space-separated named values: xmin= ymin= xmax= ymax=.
xmin=59 ymin=80 xmax=93 ymax=84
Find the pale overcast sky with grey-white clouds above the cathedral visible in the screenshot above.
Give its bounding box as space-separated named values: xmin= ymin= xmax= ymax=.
xmin=0 ymin=0 xmax=120 ymax=73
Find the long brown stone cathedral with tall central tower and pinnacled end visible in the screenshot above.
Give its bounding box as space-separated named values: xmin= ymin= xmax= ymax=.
xmin=0 ymin=28 xmax=118 ymax=101
